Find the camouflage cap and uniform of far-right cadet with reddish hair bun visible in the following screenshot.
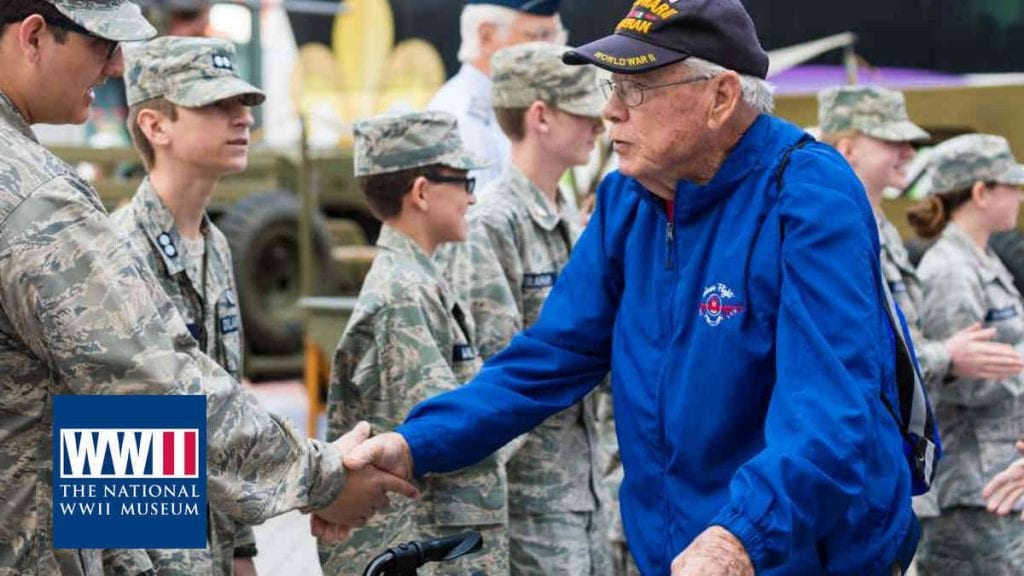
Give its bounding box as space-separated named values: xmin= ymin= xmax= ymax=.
xmin=919 ymin=134 xmax=1024 ymax=575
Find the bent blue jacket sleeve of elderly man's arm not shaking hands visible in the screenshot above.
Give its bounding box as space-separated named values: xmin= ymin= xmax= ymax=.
xmin=712 ymin=151 xmax=888 ymax=572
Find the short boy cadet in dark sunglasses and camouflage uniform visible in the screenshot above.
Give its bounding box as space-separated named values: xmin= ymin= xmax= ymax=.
xmin=321 ymin=112 xmax=509 ymax=575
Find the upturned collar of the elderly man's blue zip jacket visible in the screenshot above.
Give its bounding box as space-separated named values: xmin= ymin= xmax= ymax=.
xmin=675 ymin=114 xmax=781 ymax=220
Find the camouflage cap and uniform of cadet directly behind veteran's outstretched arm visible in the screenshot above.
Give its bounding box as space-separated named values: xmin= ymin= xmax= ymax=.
xmin=446 ymin=43 xmax=621 ymax=575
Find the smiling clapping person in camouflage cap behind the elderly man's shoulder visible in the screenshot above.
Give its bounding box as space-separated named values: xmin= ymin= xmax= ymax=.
xmin=818 ymin=86 xmax=1024 ymax=518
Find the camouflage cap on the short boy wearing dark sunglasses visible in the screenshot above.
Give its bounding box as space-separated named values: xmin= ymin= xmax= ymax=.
xmin=352 ymin=112 xmax=489 ymax=176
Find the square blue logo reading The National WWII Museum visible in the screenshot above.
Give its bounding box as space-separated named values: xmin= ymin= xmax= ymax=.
xmin=53 ymin=396 xmax=207 ymax=548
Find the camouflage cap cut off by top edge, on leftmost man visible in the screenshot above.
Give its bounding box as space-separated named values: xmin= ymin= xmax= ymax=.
xmin=46 ymin=0 xmax=157 ymax=42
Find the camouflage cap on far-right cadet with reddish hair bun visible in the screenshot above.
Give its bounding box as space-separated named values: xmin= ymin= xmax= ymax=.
xmin=924 ymin=134 xmax=1024 ymax=195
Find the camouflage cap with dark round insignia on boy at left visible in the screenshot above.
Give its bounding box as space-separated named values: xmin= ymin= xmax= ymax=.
xmin=124 ymin=36 xmax=266 ymax=108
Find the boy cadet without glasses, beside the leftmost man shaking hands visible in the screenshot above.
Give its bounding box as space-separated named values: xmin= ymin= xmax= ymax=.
xmin=103 ymin=36 xmax=265 ymax=575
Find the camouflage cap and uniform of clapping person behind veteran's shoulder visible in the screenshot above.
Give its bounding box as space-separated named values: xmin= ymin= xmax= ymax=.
xmin=818 ymin=86 xmax=937 ymax=517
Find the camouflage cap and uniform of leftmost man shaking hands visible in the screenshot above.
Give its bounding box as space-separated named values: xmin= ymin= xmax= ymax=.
xmin=0 ymin=12 xmax=344 ymax=576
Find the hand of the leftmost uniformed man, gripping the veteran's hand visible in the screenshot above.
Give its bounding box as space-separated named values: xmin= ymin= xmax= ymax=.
xmin=309 ymin=422 xmax=420 ymax=542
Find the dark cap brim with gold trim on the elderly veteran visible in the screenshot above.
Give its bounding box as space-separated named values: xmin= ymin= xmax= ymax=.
xmin=562 ymin=33 xmax=690 ymax=74
